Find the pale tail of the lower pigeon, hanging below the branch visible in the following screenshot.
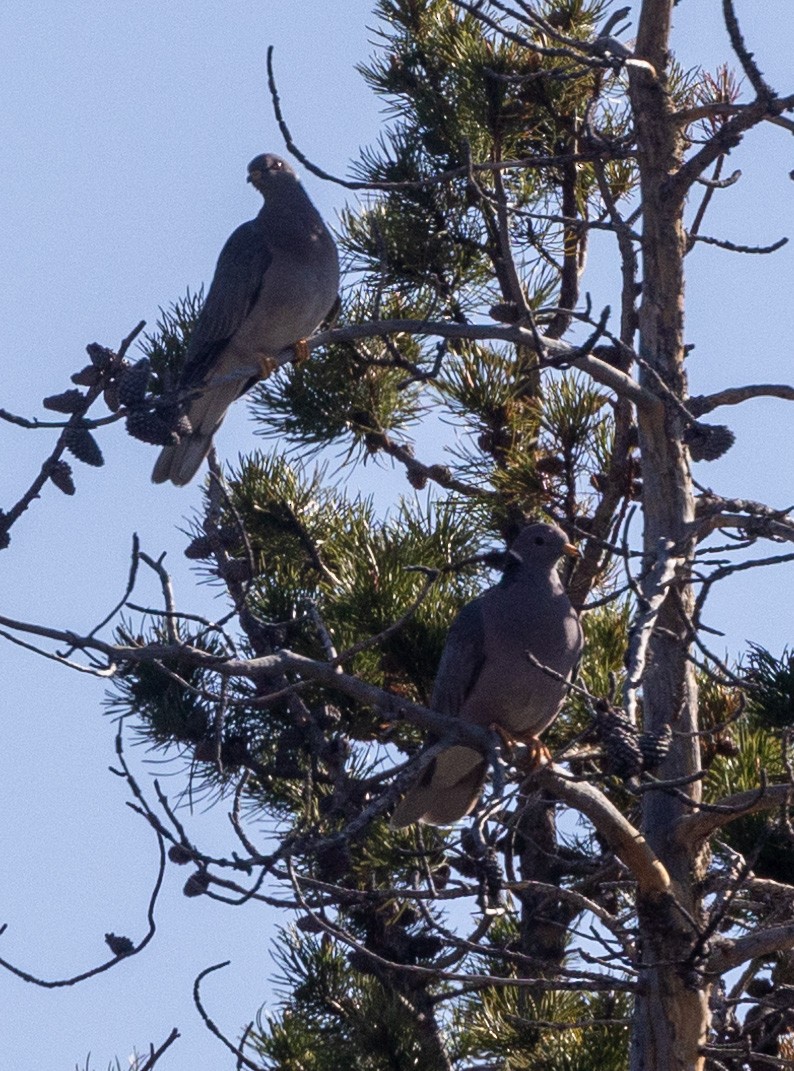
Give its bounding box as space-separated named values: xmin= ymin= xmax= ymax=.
xmin=389 ymin=745 xmax=488 ymax=829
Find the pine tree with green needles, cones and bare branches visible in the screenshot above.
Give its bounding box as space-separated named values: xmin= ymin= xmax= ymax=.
xmin=1 ymin=0 xmax=794 ymax=1071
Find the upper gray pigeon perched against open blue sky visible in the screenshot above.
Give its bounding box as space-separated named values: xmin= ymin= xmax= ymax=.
xmin=152 ymin=153 xmax=339 ymax=486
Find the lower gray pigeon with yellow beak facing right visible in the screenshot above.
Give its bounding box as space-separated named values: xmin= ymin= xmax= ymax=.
xmin=391 ymin=524 xmax=582 ymax=829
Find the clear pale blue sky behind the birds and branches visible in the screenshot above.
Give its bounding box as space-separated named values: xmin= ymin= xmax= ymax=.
xmin=0 ymin=0 xmax=794 ymax=1071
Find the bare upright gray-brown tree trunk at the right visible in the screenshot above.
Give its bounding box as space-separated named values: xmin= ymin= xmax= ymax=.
xmin=630 ymin=0 xmax=709 ymax=1071
